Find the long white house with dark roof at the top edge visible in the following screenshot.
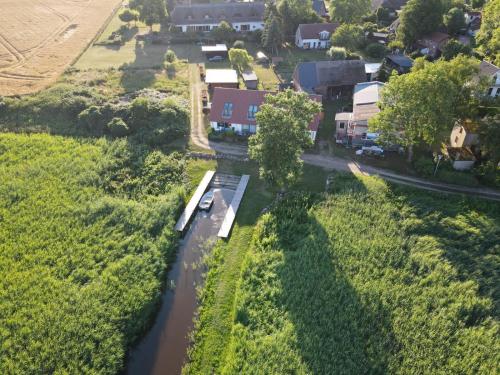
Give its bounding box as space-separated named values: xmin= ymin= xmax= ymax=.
xmin=171 ymin=2 xmax=265 ymax=32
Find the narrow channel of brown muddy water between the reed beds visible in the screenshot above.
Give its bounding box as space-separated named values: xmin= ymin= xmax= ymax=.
xmin=126 ymin=189 xmax=234 ymax=375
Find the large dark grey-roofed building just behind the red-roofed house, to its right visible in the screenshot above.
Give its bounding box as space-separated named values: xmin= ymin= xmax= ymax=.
xmin=293 ymin=60 xmax=366 ymax=99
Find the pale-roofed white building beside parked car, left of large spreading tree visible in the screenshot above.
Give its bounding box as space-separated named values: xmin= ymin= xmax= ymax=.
xmin=335 ymin=82 xmax=384 ymax=145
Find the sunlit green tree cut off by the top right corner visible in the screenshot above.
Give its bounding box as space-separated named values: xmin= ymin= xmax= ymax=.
xmin=476 ymin=0 xmax=500 ymax=64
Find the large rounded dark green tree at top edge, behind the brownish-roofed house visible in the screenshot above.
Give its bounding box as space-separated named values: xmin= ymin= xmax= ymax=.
xmin=397 ymin=0 xmax=444 ymax=48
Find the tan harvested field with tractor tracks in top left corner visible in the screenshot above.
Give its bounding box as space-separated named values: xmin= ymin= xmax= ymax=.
xmin=0 ymin=0 xmax=121 ymax=95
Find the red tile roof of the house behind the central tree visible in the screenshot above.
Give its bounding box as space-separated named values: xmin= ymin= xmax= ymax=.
xmin=210 ymin=87 xmax=322 ymax=131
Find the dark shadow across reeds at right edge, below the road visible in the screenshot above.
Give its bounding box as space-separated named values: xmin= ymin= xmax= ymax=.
xmin=389 ymin=184 xmax=500 ymax=319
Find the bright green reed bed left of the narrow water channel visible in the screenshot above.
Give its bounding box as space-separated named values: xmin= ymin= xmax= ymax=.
xmin=0 ymin=134 xmax=184 ymax=374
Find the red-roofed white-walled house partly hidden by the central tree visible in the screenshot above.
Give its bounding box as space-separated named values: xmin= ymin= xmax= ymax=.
xmin=210 ymin=87 xmax=323 ymax=141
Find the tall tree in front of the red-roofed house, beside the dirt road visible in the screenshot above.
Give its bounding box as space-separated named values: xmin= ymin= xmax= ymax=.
xmin=248 ymin=90 xmax=321 ymax=188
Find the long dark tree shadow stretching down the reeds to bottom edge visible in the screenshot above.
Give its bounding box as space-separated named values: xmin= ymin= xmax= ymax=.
xmin=264 ymin=193 xmax=396 ymax=374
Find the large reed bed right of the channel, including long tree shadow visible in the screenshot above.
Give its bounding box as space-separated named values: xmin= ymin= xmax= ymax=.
xmin=204 ymin=175 xmax=500 ymax=374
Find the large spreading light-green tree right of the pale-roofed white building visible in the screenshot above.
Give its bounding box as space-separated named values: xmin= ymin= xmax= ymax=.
xmin=369 ymin=56 xmax=477 ymax=161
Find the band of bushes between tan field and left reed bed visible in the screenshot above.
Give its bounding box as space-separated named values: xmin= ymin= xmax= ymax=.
xmin=0 ymin=63 xmax=189 ymax=145
